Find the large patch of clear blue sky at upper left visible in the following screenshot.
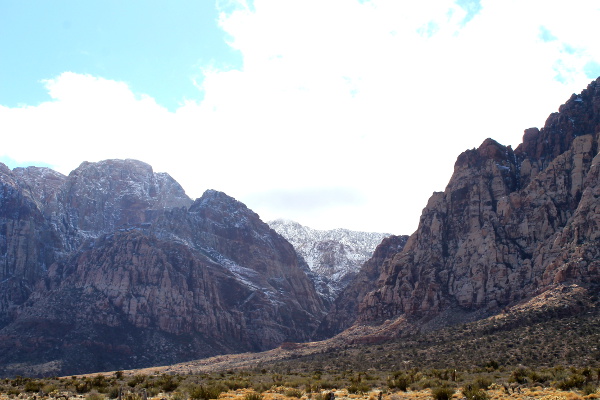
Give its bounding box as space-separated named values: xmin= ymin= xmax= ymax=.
xmin=0 ymin=0 xmax=242 ymax=111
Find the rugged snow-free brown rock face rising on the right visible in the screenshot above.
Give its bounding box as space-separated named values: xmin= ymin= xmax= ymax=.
xmin=359 ymin=80 xmax=600 ymax=324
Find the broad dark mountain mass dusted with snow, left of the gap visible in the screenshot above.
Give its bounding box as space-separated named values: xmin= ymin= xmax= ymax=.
xmin=0 ymin=160 xmax=324 ymax=375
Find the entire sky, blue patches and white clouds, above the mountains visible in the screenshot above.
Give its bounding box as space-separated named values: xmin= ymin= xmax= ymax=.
xmin=0 ymin=0 xmax=600 ymax=234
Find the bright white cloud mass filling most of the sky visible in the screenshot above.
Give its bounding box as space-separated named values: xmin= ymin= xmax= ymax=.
xmin=0 ymin=0 xmax=600 ymax=233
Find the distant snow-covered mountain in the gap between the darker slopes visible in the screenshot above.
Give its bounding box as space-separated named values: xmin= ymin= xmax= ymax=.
xmin=268 ymin=219 xmax=390 ymax=302
